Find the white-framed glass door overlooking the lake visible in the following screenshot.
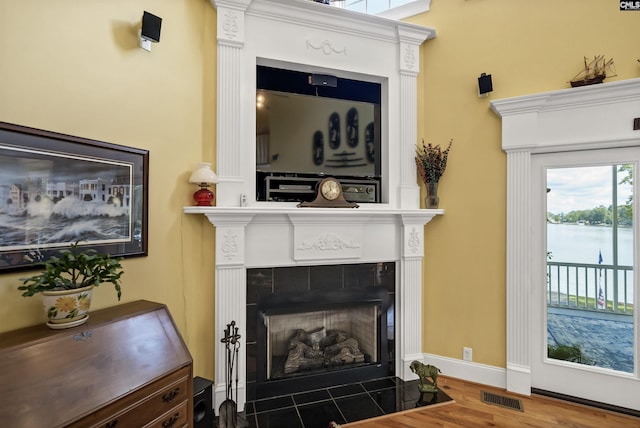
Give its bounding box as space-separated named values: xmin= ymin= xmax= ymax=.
xmin=532 ymin=149 xmax=640 ymax=410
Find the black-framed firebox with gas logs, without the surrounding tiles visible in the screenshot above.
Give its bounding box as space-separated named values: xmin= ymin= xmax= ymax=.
xmin=256 ymin=287 xmax=390 ymax=398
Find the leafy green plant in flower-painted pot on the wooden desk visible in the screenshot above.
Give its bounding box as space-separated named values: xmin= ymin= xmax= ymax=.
xmin=18 ymin=242 xmax=124 ymax=328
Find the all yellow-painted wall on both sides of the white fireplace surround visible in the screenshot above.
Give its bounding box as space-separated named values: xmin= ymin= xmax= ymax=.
xmin=0 ymin=0 xmax=640 ymax=378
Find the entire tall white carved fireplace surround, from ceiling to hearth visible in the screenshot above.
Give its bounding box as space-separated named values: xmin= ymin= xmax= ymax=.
xmin=184 ymin=0 xmax=444 ymax=408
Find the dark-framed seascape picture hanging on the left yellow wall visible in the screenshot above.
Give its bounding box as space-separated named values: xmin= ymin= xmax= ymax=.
xmin=0 ymin=122 xmax=149 ymax=271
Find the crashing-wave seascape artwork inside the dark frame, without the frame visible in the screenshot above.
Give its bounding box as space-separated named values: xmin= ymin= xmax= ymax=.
xmin=0 ymin=144 xmax=136 ymax=252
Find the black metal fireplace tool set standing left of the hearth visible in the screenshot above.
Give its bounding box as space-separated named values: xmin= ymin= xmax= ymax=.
xmin=218 ymin=321 xmax=247 ymax=428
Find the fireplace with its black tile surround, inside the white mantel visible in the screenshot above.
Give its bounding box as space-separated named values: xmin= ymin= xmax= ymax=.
xmin=246 ymin=262 xmax=396 ymax=401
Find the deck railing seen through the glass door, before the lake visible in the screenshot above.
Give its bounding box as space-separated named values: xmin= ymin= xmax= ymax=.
xmin=547 ymin=261 xmax=633 ymax=315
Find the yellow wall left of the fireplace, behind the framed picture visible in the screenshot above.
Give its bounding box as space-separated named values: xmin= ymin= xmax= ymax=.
xmin=0 ymin=0 xmax=216 ymax=378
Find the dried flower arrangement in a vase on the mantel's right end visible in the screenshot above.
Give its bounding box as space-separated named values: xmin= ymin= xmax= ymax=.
xmin=416 ymin=140 xmax=453 ymax=208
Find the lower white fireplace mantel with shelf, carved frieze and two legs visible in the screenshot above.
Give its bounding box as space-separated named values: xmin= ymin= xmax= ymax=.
xmin=184 ymin=207 xmax=444 ymax=406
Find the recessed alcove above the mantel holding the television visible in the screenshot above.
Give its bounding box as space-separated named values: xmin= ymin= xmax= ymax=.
xmin=256 ymin=65 xmax=385 ymax=203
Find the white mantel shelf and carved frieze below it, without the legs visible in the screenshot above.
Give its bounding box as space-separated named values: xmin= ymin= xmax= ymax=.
xmin=184 ymin=206 xmax=444 ymax=266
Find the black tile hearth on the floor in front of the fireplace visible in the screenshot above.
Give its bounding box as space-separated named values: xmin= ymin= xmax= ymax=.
xmin=245 ymin=377 xmax=452 ymax=428
